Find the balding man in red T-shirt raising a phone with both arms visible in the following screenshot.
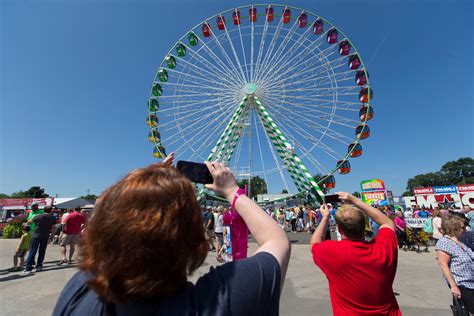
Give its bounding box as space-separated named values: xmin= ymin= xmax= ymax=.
xmin=311 ymin=192 xmax=401 ymax=315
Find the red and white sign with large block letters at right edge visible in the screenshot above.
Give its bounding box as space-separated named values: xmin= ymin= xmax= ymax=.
xmin=403 ymin=184 xmax=474 ymax=208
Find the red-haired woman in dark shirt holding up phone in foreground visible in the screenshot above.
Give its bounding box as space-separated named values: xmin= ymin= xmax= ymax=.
xmin=53 ymin=154 xmax=290 ymax=315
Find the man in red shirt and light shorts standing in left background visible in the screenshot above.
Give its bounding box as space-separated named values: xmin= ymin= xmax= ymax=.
xmin=58 ymin=207 xmax=86 ymax=265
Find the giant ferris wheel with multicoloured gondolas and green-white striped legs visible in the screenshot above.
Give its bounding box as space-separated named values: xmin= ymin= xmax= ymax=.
xmin=147 ymin=5 xmax=374 ymax=200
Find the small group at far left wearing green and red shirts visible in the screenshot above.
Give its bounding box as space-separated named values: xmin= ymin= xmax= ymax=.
xmin=10 ymin=203 xmax=88 ymax=274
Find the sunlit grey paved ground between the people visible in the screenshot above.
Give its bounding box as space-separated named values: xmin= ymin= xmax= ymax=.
xmin=0 ymin=232 xmax=452 ymax=316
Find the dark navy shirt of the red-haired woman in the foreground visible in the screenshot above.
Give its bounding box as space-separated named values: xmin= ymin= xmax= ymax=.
xmin=53 ymin=252 xmax=281 ymax=316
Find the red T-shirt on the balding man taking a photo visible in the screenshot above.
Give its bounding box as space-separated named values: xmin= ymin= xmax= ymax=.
xmin=312 ymin=228 xmax=401 ymax=315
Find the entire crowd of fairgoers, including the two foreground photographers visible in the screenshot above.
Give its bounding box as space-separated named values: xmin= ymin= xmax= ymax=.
xmin=4 ymin=154 xmax=474 ymax=315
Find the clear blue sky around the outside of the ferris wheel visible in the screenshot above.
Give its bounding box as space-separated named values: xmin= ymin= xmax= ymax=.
xmin=0 ymin=0 xmax=474 ymax=197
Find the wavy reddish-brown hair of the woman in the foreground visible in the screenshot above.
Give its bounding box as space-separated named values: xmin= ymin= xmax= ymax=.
xmin=79 ymin=164 xmax=208 ymax=303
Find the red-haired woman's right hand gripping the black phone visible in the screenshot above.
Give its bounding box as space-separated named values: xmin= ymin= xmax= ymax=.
xmin=204 ymin=161 xmax=239 ymax=201
